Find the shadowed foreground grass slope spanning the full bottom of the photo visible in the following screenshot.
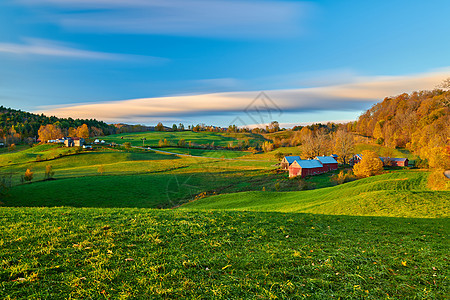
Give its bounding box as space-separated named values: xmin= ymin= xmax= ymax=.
xmin=0 ymin=208 xmax=450 ymax=299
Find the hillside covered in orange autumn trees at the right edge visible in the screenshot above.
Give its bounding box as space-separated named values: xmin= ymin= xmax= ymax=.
xmin=353 ymin=89 xmax=450 ymax=168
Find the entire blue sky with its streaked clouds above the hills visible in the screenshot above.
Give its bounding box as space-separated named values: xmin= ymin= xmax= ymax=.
xmin=0 ymin=0 xmax=450 ymax=126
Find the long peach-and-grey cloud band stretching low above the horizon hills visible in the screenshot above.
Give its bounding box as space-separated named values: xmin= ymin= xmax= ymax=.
xmin=39 ymin=70 xmax=450 ymax=124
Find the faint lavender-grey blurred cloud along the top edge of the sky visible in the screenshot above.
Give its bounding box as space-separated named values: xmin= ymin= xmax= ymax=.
xmin=16 ymin=0 xmax=314 ymax=38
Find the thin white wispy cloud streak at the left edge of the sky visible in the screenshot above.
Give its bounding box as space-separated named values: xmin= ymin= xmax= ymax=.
xmin=0 ymin=38 xmax=165 ymax=62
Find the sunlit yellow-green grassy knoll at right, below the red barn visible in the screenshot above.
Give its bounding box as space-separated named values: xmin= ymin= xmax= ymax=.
xmin=183 ymin=171 xmax=450 ymax=217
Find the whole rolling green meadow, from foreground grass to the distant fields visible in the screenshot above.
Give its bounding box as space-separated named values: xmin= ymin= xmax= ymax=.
xmin=0 ymin=138 xmax=450 ymax=299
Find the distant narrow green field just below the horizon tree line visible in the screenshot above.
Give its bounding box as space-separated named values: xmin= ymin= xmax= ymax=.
xmin=101 ymin=131 xmax=265 ymax=147
